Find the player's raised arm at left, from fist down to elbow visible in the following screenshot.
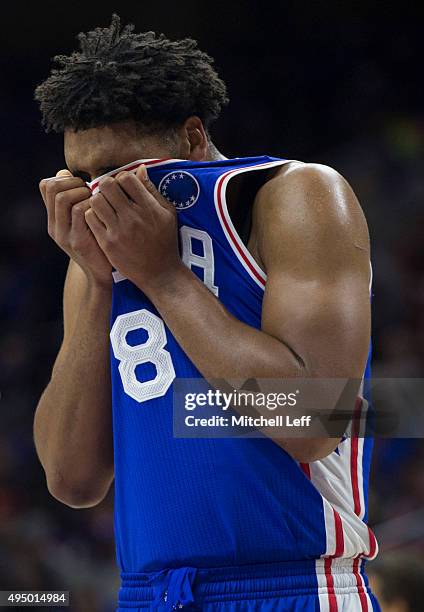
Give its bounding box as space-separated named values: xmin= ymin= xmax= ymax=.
xmin=34 ymin=172 xmax=113 ymax=508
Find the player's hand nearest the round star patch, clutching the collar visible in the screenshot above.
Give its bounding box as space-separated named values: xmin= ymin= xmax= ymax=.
xmin=85 ymin=166 xmax=183 ymax=295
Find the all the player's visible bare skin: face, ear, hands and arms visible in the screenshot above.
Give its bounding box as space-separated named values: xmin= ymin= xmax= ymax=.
xmin=35 ymin=117 xmax=370 ymax=507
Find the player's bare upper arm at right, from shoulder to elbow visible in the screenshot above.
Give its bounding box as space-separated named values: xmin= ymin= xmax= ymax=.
xmin=255 ymin=164 xmax=371 ymax=461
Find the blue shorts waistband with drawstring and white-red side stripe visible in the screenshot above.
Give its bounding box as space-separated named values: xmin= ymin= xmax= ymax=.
xmin=119 ymin=559 xmax=368 ymax=612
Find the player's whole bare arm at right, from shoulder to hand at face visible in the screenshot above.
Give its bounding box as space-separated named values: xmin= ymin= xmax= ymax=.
xmin=87 ymin=164 xmax=370 ymax=461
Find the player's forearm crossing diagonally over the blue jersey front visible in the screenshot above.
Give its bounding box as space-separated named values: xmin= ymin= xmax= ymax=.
xmin=144 ymin=266 xmax=305 ymax=379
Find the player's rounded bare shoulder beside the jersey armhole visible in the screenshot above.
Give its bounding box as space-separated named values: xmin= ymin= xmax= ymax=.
xmin=251 ymin=162 xmax=370 ymax=277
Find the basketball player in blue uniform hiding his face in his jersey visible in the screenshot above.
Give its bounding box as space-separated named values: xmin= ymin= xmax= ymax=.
xmin=35 ymin=16 xmax=378 ymax=612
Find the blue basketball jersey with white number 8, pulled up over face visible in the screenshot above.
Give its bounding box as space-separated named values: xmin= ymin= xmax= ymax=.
xmin=91 ymin=156 xmax=377 ymax=573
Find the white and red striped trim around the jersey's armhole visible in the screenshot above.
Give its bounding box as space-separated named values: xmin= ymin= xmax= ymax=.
xmin=214 ymin=159 xmax=296 ymax=290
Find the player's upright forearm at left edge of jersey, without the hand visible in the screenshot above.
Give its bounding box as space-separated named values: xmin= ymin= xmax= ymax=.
xmin=34 ymin=286 xmax=113 ymax=502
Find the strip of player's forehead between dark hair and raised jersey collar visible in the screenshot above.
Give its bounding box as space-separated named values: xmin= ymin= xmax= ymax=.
xmin=64 ymin=122 xmax=172 ymax=177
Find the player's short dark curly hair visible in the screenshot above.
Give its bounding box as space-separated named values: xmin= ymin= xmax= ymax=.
xmin=35 ymin=15 xmax=228 ymax=132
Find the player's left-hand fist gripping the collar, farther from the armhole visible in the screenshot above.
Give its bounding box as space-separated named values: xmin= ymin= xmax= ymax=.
xmin=40 ymin=170 xmax=112 ymax=285
